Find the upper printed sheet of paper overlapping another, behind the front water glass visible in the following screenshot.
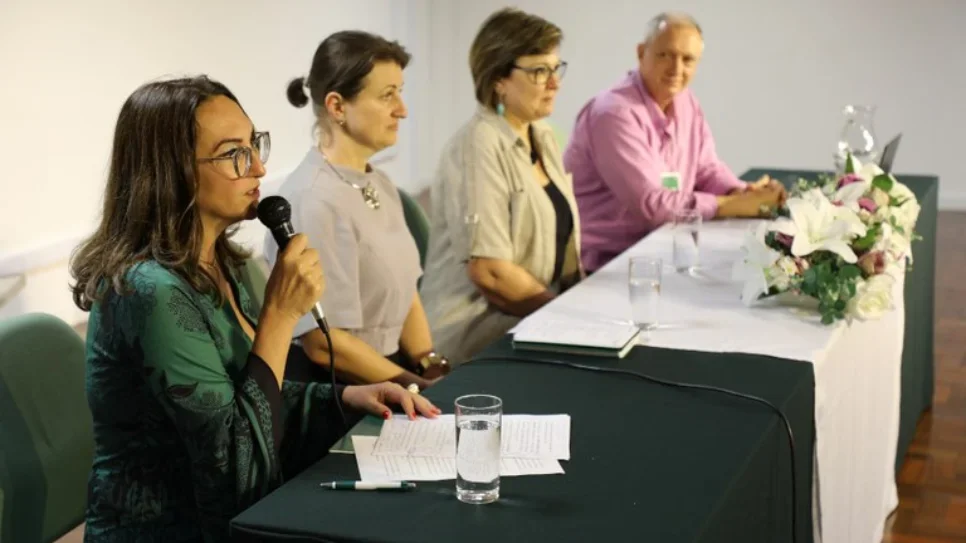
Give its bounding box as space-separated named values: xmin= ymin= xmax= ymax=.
xmin=373 ymin=415 xmax=570 ymax=460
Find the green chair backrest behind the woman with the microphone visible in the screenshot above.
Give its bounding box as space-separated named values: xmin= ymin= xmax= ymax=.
xmin=0 ymin=313 xmax=94 ymax=543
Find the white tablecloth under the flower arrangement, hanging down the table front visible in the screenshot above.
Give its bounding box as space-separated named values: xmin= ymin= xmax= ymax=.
xmin=517 ymin=221 xmax=905 ymax=543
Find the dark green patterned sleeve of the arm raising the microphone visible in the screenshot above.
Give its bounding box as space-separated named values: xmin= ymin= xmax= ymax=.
xmin=133 ymin=282 xmax=284 ymax=541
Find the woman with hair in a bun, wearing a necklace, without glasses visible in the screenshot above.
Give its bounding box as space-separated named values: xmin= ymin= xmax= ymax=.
xmin=265 ymin=31 xmax=449 ymax=389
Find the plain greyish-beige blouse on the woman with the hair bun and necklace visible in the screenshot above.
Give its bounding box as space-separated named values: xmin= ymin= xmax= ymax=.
xmin=265 ymin=147 xmax=422 ymax=356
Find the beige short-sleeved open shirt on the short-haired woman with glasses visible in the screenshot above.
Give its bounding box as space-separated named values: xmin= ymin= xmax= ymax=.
xmin=420 ymin=107 xmax=582 ymax=364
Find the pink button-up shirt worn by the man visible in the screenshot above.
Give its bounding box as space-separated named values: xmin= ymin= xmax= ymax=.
xmin=564 ymin=70 xmax=745 ymax=272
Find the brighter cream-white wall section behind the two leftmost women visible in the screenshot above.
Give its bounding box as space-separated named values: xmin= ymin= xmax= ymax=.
xmin=0 ymin=0 xmax=429 ymax=322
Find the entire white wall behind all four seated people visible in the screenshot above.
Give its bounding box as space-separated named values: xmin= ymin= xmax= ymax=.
xmin=0 ymin=0 xmax=966 ymax=322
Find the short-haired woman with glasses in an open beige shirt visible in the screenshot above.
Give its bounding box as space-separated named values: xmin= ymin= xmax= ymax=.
xmin=421 ymin=8 xmax=583 ymax=364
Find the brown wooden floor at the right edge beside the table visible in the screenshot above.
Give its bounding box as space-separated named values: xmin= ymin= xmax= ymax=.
xmin=883 ymin=212 xmax=966 ymax=543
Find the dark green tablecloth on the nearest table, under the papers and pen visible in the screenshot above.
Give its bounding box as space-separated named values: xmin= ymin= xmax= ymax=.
xmin=232 ymin=340 xmax=814 ymax=543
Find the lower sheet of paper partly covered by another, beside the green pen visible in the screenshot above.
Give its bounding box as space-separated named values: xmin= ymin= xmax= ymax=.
xmin=352 ymin=436 xmax=564 ymax=482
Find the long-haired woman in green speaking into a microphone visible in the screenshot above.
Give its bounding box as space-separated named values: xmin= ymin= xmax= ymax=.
xmin=71 ymin=77 xmax=439 ymax=543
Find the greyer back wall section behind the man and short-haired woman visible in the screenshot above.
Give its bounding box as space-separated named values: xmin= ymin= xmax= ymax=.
xmin=424 ymin=0 xmax=966 ymax=209
